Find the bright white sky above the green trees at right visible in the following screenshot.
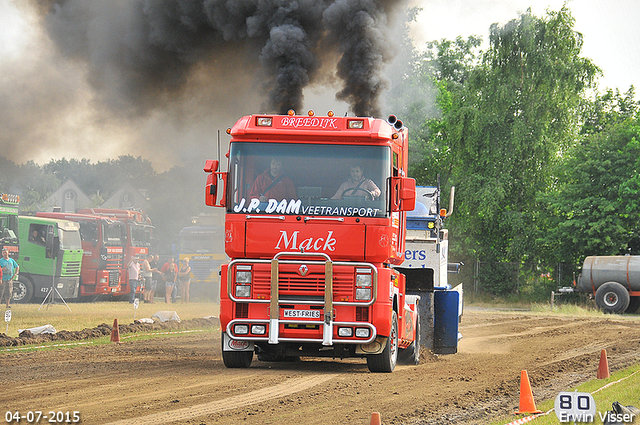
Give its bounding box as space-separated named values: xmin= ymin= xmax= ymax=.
xmin=411 ymin=0 xmax=640 ymax=92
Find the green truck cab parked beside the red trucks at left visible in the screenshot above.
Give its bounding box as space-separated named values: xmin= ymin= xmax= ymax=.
xmin=13 ymin=215 xmax=83 ymax=303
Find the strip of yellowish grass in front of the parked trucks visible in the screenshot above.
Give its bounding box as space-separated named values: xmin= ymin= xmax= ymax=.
xmin=0 ymin=300 xmax=219 ymax=337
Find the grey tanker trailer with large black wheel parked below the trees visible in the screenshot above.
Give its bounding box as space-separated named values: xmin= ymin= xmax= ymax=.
xmin=575 ymin=255 xmax=640 ymax=313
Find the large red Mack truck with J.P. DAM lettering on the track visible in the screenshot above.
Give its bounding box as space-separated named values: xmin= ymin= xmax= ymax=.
xmin=204 ymin=112 xmax=420 ymax=372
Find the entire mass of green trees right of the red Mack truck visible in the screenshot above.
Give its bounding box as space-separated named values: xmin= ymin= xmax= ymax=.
xmin=392 ymin=7 xmax=640 ymax=296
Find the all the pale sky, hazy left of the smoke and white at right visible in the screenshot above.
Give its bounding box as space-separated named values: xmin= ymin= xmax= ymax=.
xmin=0 ymin=0 xmax=640 ymax=171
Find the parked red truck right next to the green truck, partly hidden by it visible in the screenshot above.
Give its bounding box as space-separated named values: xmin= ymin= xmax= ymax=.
xmin=36 ymin=212 xmax=125 ymax=297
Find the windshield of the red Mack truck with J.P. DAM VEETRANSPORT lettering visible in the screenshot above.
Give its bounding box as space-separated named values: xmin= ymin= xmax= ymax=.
xmin=227 ymin=142 xmax=391 ymax=217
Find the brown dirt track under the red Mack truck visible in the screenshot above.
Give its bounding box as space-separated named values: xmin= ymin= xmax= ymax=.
xmin=0 ymin=309 xmax=640 ymax=425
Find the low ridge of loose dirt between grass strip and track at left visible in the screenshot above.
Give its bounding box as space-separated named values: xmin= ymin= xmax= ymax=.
xmin=0 ymin=317 xmax=220 ymax=347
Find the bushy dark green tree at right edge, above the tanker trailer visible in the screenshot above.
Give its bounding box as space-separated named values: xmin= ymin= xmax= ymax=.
xmin=542 ymin=88 xmax=640 ymax=265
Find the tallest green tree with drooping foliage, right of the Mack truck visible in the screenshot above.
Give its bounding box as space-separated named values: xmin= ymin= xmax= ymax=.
xmin=446 ymin=7 xmax=599 ymax=292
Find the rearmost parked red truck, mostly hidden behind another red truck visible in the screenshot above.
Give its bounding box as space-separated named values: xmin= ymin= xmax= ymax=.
xmin=77 ymin=208 xmax=153 ymax=295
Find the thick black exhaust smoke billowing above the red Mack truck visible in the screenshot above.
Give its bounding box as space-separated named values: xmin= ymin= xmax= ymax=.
xmin=38 ymin=0 xmax=404 ymax=116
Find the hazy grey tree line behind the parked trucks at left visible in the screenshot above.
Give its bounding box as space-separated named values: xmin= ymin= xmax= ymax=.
xmin=0 ymin=155 xmax=206 ymax=254
